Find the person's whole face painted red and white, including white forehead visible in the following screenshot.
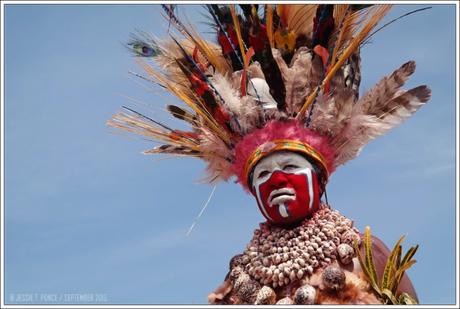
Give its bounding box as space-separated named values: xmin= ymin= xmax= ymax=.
xmin=251 ymin=151 xmax=319 ymax=225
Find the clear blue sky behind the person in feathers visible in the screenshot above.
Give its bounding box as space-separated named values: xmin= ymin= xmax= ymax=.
xmin=4 ymin=4 xmax=458 ymax=304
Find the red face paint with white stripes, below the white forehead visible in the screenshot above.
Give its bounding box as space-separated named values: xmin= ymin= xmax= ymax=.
xmin=253 ymin=167 xmax=319 ymax=225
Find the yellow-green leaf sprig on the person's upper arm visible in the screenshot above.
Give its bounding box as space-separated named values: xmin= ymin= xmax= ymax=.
xmin=354 ymin=226 xmax=418 ymax=305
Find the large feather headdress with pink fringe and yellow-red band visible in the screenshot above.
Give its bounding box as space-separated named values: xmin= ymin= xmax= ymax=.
xmin=108 ymin=4 xmax=430 ymax=188
